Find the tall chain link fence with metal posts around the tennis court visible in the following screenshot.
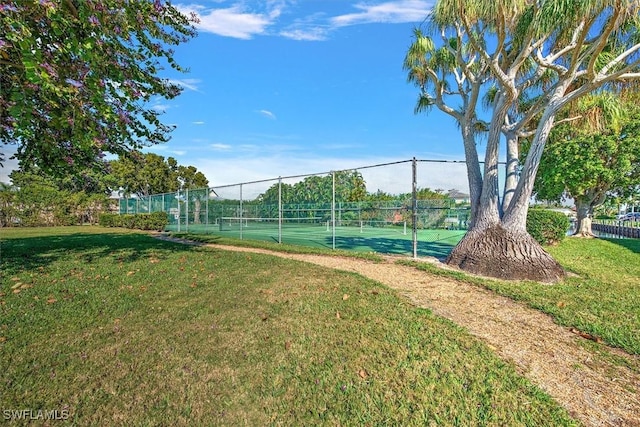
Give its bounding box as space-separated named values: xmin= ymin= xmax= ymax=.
xmin=120 ymin=159 xmax=480 ymax=258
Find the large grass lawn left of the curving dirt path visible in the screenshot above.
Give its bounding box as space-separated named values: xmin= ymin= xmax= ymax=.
xmin=0 ymin=227 xmax=576 ymax=426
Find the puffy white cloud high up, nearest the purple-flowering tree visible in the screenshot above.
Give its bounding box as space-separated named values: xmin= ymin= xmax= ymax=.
xmin=177 ymin=5 xmax=281 ymax=40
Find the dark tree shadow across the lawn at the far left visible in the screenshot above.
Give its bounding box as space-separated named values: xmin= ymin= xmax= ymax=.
xmin=0 ymin=233 xmax=198 ymax=278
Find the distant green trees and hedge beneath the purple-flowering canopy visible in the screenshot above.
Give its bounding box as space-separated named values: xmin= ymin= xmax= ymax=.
xmin=0 ymin=152 xmax=209 ymax=227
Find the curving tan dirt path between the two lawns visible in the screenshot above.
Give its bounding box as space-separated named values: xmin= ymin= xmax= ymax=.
xmin=155 ymin=237 xmax=640 ymax=426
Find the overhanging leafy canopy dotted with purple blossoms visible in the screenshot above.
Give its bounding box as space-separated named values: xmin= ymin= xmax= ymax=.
xmin=0 ymin=0 xmax=196 ymax=175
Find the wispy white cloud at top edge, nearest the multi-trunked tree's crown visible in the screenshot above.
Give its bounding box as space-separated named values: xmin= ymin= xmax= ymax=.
xmin=331 ymin=0 xmax=432 ymax=27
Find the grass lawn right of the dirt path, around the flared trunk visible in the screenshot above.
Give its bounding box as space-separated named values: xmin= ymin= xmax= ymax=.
xmin=404 ymin=238 xmax=640 ymax=354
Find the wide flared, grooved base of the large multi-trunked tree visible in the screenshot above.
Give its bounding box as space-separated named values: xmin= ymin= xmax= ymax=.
xmin=446 ymin=224 xmax=565 ymax=283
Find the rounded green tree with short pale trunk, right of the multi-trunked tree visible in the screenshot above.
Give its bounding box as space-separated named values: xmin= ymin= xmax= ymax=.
xmin=534 ymin=92 xmax=640 ymax=235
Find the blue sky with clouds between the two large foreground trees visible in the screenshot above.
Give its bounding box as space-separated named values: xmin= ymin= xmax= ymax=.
xmin=0 ymin=0 xmax=467 ymax=195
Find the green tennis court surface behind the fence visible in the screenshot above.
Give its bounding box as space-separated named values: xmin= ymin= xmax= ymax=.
xmin=167 ymin=224 xmax=466 ymax=258
